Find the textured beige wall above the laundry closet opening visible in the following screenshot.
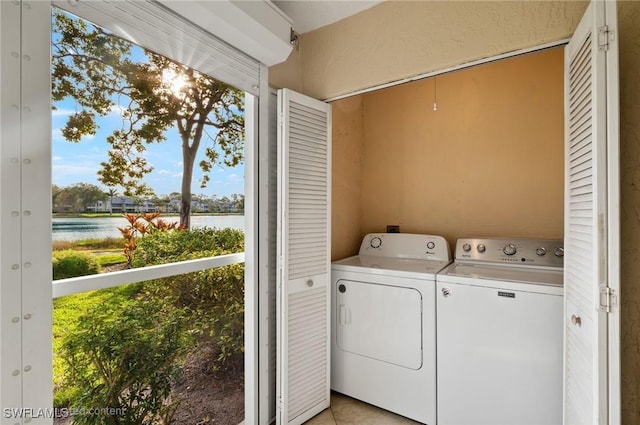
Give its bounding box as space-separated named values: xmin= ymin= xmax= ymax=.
xmin=274 ymin=1 xmax=586 ymax=99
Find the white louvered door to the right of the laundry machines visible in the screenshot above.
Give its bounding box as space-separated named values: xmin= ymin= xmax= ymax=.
xmin=564 ymin=1 xmax=620 ymax=425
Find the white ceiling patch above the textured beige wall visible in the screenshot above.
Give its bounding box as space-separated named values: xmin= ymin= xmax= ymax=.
xmin=273 ymin=0 xmax=382 ymax=34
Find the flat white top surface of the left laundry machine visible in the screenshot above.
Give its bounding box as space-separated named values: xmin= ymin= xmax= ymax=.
xmin=331 ymin=255 xmax=449 ymax=279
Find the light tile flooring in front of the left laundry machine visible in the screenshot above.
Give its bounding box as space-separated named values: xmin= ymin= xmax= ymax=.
xmin=305 ymin=392 xmax=419 ymax=425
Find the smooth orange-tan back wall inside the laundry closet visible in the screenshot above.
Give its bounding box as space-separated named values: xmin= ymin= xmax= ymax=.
xmin=360 ymin=48 xmax=564 ymax=246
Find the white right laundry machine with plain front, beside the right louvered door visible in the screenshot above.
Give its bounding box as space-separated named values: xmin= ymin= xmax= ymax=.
xmin=436 ymin=239 xmax=564 ymax=425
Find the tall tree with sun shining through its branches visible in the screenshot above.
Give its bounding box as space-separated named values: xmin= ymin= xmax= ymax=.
xmin=52 ymin=10 xmax=244 ymax=228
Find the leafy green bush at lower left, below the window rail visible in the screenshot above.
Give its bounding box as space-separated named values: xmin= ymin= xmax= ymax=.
xmin=62 ymin=299 xmax=186 ymax=425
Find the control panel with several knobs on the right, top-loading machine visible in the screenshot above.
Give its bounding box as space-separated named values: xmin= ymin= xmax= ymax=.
xmin=455 ymin=238 xmax=564 ymax=267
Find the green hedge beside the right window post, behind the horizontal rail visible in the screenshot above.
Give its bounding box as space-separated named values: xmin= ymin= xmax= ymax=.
xmin=133 ymin=228 xmax=244 ymax=366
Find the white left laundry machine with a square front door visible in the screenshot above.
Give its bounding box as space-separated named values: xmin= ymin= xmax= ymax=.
xmin=331 ymin=233 xmax=451 ymax=424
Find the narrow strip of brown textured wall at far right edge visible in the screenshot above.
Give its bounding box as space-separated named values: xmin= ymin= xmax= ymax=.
xmin=618 ymin=1 xmax=640 ymax=425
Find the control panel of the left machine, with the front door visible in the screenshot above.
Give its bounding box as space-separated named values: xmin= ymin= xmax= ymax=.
xmin=359 ymin=233 xmax=451 ymax=261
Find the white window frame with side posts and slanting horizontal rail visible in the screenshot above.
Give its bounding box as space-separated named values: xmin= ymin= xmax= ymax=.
xmin=0 ymin=0 xmax=269 ymax=424
